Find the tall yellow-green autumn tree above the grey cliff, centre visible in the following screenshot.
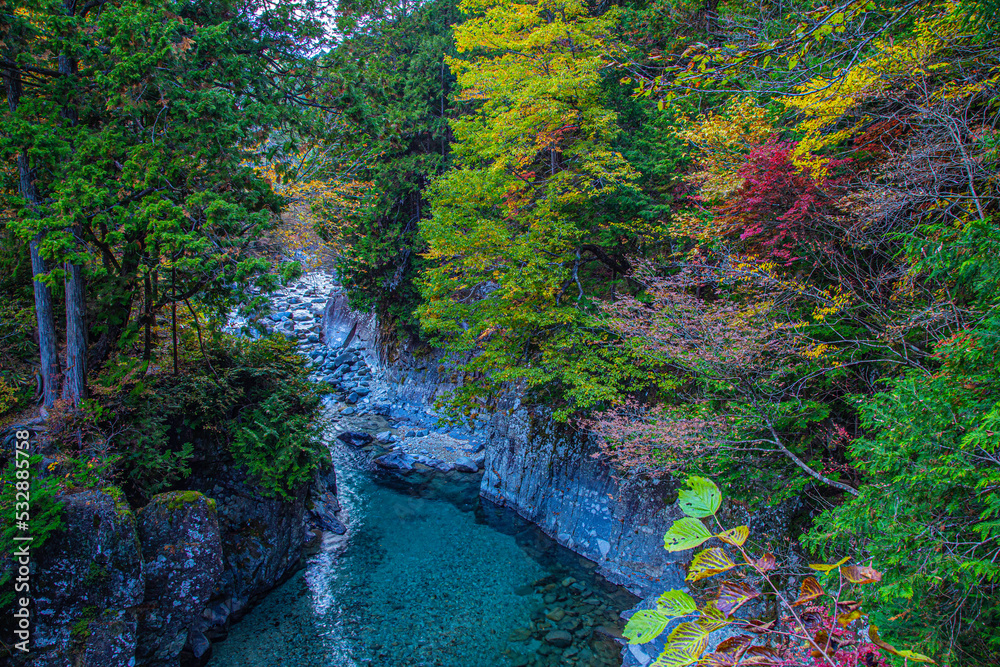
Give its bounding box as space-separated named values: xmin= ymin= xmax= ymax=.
xmin=418 ymin=2 xmax=676 ymax=417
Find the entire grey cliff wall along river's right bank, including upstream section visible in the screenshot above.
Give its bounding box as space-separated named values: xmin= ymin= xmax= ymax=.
xmin=324 ymin=296 xmax=692 ymax=595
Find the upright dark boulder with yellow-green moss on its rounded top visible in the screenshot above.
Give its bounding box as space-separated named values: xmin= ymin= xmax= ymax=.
xmin=137 ymin=491 xmax=223 ymax=667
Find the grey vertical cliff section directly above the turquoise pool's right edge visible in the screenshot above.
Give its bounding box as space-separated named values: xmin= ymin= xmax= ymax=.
xmin=480 ymin=399 xmax=681 ymax=595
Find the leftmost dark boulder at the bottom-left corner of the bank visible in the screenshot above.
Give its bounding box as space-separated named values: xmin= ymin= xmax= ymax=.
xmin=31 ymin=491 xmax=144 ymax=667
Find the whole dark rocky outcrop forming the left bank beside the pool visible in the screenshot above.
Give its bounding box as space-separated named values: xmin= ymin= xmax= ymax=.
xmin=15 ymin=465 xmax=339 ymax=667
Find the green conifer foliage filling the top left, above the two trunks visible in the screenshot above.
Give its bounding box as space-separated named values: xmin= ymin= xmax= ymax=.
xmin=0 ymin=0 xmax=320 ymax=370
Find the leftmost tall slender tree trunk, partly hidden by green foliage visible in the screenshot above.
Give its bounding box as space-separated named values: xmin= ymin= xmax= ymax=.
xmin=3 ymin=62 xmax=60 ymax=408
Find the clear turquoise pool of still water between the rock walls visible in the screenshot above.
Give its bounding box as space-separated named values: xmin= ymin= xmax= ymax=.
xmin=209 ymin=445 xmax=637 ymax=667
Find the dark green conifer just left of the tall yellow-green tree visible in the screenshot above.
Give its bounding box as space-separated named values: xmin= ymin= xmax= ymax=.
xmin=323 ymin=0 xmax=462 ymax=333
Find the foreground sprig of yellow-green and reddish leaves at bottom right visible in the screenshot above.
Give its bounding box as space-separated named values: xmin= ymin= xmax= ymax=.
xmin=624 ymin=477 xmax=920 ymax=667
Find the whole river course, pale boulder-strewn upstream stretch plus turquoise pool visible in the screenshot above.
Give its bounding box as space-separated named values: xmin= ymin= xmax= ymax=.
xmin=212 ymin=273 xmax=635 ymax=667
